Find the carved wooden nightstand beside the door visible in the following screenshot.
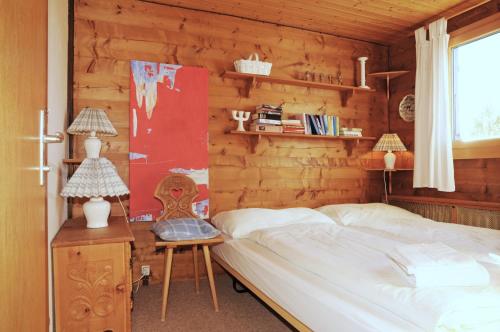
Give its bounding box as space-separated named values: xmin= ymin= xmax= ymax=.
xmin=52 ymin=217 xmax=134 ymax=332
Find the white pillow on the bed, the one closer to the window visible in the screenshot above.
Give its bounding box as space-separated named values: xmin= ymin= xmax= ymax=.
xmin=316 ymin=203 xmax=423 ymax=226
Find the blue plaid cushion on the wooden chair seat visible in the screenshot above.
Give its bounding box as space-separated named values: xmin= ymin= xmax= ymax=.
xmin=151 ymin=218 xmax=220 ymax=241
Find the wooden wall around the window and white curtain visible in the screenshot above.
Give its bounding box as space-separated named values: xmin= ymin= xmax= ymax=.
xmin=389 ymin=0 xmax=500 ymax=202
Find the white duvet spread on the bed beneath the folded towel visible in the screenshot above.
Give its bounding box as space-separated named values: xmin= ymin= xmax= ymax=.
xmin=250 ymin=224 xmax=500 ymax=332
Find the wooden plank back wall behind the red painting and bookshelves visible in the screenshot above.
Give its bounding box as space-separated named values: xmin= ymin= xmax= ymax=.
xmin=74 ymin=0 xmax=388 ymax=278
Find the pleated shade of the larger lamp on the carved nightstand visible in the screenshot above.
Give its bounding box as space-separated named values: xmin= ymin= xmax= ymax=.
xmin=61 ymin=158 xmax=129 ymax=197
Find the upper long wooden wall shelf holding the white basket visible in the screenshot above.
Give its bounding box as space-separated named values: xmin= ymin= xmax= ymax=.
xmin=222 ymin=71 xmax=376 ymax=100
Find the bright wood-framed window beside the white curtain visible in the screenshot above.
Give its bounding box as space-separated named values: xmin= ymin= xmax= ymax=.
xmin=450 ymin=15 xmax=500 ymax=159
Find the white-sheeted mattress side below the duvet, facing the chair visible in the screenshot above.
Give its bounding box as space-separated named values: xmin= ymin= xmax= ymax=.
xmin=213 ymin=235 xmax=422 ymax=332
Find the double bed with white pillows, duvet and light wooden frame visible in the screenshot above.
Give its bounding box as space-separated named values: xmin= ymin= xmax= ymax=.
xmin=212 ymin=204 xmax=500 ymax=331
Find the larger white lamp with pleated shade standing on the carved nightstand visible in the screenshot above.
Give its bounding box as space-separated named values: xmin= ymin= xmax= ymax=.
xmin=61 ymin=158 xmax=129 ymax=228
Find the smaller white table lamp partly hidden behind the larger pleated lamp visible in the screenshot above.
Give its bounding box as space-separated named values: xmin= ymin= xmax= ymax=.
xmin=67 ymin=107 xmax=118 ymax=158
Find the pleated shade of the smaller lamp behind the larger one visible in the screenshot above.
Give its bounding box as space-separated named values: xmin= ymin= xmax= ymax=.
xmin=67 ymin=107 xmax=118 ymax=136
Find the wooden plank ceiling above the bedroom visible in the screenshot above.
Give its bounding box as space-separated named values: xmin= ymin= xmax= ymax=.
xmin=145 ymin=0 xmax=487 ymax=45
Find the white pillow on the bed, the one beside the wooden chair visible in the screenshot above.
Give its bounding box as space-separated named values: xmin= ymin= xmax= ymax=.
xmin=211 ymin=208 xmax=334 ymax=238
